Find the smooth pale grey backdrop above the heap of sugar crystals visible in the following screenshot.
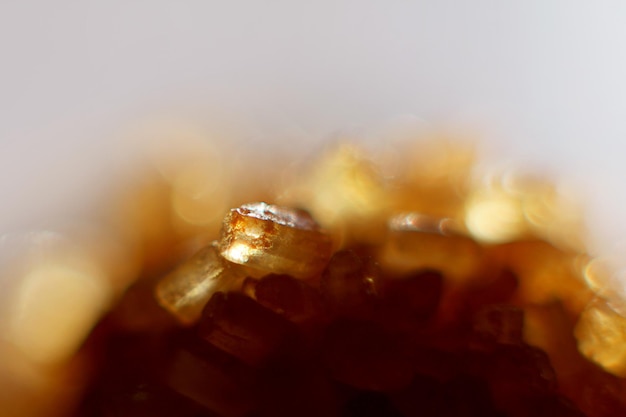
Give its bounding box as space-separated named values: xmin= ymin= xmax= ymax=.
xmin=0 ymin=0 xmax=626 ymax=254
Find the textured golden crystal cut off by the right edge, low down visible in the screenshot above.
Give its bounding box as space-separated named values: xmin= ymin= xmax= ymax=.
xmin=574 ymin=299 xmax=626 ymax=377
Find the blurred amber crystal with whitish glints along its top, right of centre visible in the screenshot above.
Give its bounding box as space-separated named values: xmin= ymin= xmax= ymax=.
xmin=381 ymin=213 xmax=481 ymax=279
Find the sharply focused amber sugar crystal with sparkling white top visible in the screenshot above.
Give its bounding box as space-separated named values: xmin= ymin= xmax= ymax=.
xmin=219 ymin=203 xmax=332 ymax=278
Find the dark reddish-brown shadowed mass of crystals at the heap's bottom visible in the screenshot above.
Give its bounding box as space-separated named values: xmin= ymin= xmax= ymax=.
xmin=74 ymin=244 xmax=608 ymax=417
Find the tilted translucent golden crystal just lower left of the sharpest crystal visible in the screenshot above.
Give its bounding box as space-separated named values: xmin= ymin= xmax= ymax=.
xmin=156 ymin=244 xmax=243 ymax=325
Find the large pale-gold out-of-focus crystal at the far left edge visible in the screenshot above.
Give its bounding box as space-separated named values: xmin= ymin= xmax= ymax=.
xmin=2 ymin=232 xmax=113 ymax=365
